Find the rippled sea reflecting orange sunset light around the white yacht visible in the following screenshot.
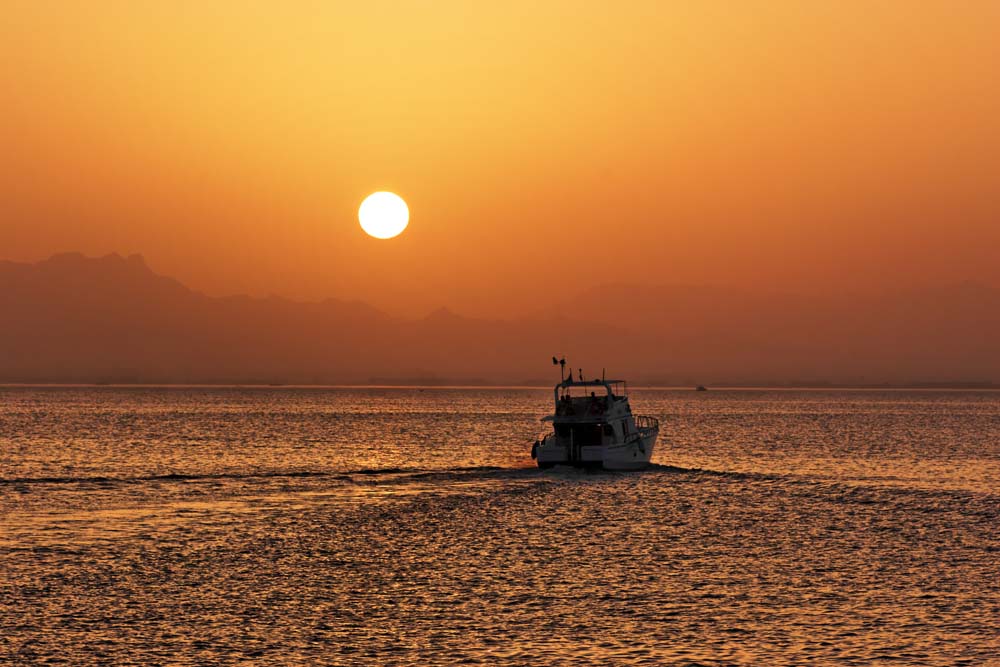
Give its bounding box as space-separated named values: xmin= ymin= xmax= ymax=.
xmin=0 ymin=386 xmax=1000 ymax=666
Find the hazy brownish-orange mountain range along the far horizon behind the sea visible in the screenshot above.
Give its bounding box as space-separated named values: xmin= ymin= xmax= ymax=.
xmin=0 ymin=253 xmax=1000 ymax=385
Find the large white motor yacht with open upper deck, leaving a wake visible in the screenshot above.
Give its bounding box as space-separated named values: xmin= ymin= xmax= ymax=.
xmin=531 ymin=359 xmax=660 ymax=470
